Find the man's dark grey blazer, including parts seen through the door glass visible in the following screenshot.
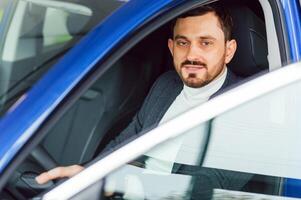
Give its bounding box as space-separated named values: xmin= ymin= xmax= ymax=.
xmin=104 ymin=70 xmax=252 ymax=199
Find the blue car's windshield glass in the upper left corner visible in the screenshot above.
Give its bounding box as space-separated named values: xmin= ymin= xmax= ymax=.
xmin=0 ymin=0 xmax=124 ymax=115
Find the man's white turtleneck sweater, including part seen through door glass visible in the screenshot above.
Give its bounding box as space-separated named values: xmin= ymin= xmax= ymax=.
xmin=146 ymin=68 xmax=227 ymax=173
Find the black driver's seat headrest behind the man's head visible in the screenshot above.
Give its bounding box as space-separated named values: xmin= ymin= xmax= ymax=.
xmin=228 ymin=5 xmax=269 ymax=77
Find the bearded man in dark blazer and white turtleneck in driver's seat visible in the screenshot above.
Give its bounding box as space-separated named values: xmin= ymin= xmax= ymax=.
xmin=36 ymin=6 xmax=250 ymax=194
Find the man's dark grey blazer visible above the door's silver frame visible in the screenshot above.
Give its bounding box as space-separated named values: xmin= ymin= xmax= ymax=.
xmin=105 ymin=70 xmax=241 ymax=150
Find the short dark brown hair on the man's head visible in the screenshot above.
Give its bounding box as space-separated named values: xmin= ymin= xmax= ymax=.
xmin=171 ymin=3 xmax=233 ymax=41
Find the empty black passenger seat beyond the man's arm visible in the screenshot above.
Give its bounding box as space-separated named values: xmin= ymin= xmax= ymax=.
xmin=43 ymin=23 xmax=165 ymax=165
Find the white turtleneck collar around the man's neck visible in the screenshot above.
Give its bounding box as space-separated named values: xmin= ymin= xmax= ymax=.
xmin=181 ymin=68 xmax=227 ymax=106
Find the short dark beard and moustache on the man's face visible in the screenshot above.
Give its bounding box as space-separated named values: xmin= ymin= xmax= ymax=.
xmin=178 ymin=54 xmax=225 ymax=88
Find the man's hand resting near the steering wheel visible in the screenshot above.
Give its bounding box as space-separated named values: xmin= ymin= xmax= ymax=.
xmin=36 ymin=165 xmax=84 ymax=184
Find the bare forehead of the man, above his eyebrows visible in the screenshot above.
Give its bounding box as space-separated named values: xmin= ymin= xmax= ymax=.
xmin=174 ymin=12 xmax=224 ymax=39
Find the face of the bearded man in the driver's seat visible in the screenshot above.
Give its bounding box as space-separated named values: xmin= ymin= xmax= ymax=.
xmin=168 ymin=12 xmax=236 ymax=88
